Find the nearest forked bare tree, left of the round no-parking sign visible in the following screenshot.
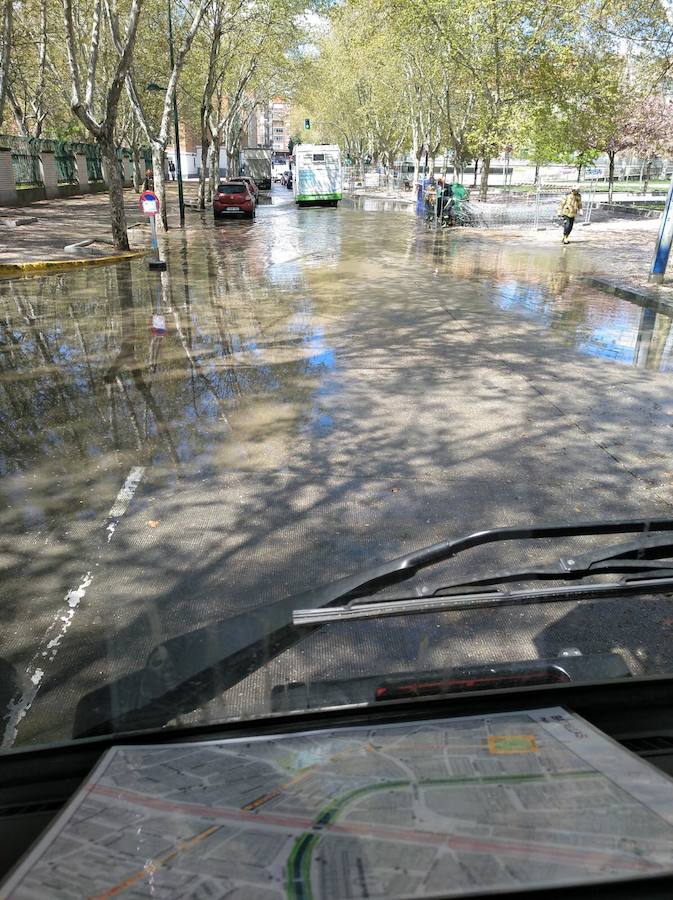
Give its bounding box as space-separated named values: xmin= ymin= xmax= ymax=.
xmin=63 ymin=0 xmax=143 ymax=250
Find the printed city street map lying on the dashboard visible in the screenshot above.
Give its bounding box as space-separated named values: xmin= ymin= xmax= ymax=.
xmin=0 ymin=708 xmax=673 ymax=900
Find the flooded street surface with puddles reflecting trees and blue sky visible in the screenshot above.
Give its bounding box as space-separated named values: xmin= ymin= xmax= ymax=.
xmin=0 ymin=186 xmax=673 ymax=746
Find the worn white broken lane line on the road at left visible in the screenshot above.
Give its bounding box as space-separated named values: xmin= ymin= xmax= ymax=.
xmin=0 ymin=466 xmax=145 ymax=749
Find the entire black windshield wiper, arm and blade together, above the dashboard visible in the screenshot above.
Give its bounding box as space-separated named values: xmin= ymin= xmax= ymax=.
xmin=74 ymin=519 xmax=673 ymax=737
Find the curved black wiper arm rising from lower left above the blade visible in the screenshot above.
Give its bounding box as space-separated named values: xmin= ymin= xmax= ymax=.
xmin=73 ymin=519 xmax=673 ymax=737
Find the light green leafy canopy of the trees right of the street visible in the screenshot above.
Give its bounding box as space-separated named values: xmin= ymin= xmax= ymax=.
xmin=297 ymin=0 xmax=673 ymax=181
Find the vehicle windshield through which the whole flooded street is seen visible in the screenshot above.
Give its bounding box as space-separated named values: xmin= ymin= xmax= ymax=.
xmin=0 ymin=0 xmax=673 ymax=750
